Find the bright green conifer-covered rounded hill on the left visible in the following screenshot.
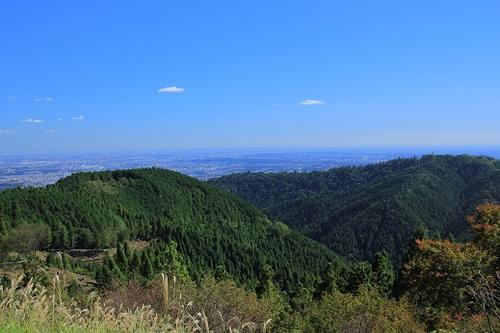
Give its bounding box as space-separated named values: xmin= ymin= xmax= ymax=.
xmin=0 ymin=169 xmax=337 ymax=287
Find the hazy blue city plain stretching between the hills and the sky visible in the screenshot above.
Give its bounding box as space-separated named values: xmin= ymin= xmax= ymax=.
xmin=0 ymin=147 xmax=500 ymax=191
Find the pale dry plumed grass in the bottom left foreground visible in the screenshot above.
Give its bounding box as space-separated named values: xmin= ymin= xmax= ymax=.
xmin=0 ymin=276 xmax=267 ymax=333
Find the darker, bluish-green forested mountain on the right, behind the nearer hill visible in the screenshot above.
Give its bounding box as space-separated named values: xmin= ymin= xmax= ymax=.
xmin=211 ymin=155 xmax=500 ymax=263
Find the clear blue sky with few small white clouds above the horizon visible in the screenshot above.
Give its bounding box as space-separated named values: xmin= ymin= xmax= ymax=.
xmin=0 ymin=0 xmax=500 ymax=152
